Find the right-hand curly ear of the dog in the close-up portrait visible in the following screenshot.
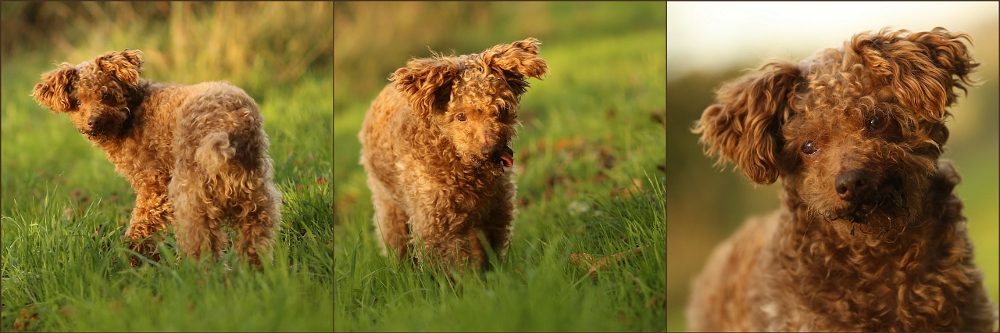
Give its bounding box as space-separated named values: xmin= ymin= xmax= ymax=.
xmin=849 ymin=27 xmax=979 ymax=122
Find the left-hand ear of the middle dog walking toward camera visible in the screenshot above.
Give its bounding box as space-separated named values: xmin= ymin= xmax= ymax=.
xmin=390 ymin=57 xmax=459 ymax=117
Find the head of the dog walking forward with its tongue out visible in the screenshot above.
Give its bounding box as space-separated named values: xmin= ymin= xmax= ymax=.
xmin=392 ymin=38 xmax=548 ymax=170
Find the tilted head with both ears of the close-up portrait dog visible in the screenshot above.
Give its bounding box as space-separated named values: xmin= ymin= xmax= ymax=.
xmin=694 ymin=28 xmax=978 ymax=233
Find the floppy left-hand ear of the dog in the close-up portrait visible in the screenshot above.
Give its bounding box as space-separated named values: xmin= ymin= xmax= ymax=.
xmin=692 ymin=60 xmax=799 ymax=184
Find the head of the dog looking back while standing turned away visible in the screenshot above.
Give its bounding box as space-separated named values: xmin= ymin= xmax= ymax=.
xmin=31 ymin=50 xmax=142 ymax=143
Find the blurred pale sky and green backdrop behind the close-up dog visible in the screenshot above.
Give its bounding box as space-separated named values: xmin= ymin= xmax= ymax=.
xmin=667 ymin=3 xmax=1000 ymax=331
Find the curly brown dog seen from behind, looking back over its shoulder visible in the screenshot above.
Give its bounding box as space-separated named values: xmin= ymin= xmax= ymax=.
xmin=32 ymin=49 xmax=281 ymax=266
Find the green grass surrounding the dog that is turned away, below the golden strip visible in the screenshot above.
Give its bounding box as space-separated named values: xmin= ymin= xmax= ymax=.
xmin=0 ymin=63 xmax=333 ymax=331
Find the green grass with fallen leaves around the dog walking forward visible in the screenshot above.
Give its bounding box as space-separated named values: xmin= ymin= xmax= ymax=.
xmin=334 ymin=29 xmax=666 ymax=331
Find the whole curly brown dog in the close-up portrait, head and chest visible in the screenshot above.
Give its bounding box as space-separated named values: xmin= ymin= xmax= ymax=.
xmin=687 ymin=28 xmax=996 ymax=331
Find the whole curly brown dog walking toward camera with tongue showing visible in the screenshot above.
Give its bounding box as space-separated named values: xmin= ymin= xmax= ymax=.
xmin=358 ymin=38 xmax=548 ymax=268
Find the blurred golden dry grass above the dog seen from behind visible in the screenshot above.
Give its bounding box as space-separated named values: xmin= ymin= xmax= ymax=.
xmin=0 ymin=2 xmax=333 ymax=95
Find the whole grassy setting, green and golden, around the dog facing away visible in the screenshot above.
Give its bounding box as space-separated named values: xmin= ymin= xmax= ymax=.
xmin=0 ymin=3 xmax=333 ymax=331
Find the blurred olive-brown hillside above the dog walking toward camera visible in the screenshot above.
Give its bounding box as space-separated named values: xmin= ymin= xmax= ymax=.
xmin=333 ymin=2 xmax=665 ymax=113
